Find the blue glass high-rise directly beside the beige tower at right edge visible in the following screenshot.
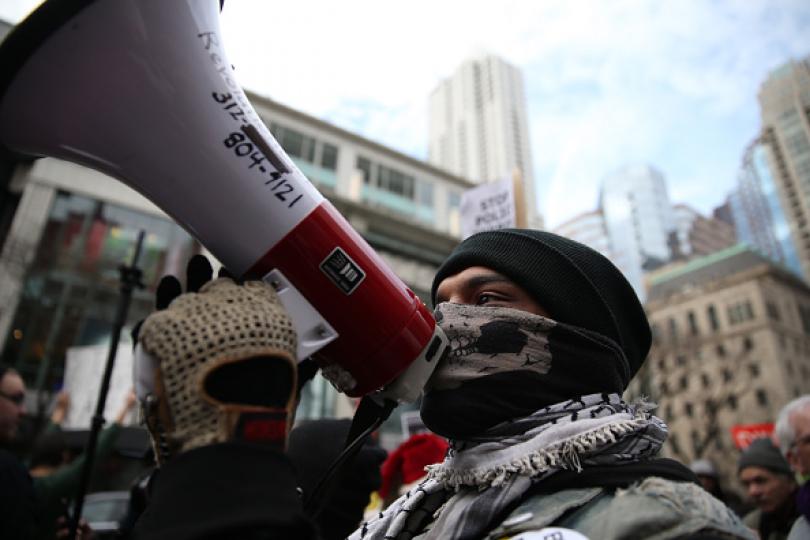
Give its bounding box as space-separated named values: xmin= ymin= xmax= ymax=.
xmin=728 ymin=139 xmax=802 ymax=276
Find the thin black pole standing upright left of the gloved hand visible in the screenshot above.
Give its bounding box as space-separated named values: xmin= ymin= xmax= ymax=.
xmin=68 ymin=231 xmax=143 ymax=540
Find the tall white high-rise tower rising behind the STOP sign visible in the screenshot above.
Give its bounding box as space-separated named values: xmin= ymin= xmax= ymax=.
xmin=428 ymin=55 xmax=542 ymax=228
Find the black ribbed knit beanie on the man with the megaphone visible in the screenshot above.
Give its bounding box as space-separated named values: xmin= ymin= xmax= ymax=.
xmin=431 ymin=229 xmax=652 ymax=377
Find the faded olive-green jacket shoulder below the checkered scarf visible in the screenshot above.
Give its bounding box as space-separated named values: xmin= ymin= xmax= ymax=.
xmin=488 ymin=476 xmax=756 ymax=540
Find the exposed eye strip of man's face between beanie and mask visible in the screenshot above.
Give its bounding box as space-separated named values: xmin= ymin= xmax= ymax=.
xmin=436 ymin=266 xmax=549 ymax=317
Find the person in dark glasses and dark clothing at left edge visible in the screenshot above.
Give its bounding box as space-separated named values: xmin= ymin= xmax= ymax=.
xmin=0 ymin=364 xmax=35 ymax=540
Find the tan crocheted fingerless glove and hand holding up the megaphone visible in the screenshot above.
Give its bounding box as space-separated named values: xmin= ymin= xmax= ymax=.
xmin=135 ymin=256 xmax=297 ymax=464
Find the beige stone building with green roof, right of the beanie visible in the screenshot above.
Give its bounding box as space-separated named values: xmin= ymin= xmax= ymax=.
xmin=631 ymin=246 xmax=810 ymax=486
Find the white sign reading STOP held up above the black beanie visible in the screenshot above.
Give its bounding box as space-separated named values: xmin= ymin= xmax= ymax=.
xmin=460 ymin=179 xmax=517 ymax=238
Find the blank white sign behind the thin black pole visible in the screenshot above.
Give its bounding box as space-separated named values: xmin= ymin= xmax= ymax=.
xmin=62 ymin=344 xmax=132 ymax=429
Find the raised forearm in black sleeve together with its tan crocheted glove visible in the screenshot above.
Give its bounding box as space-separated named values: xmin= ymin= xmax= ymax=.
xmin=132 ymin=268 xmax=317 ymax=540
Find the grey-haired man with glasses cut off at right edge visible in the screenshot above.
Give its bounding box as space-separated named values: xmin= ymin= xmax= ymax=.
xmin=774 ymin=395 xmax=810 ymax=540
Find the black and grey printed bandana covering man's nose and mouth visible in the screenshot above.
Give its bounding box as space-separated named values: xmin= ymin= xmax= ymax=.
xmin=421 ymin=303 xmax=630 ymax=440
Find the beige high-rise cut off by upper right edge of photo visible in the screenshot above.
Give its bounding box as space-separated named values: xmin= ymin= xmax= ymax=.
xmin=759 ymin=57 xmax=810 ymax=276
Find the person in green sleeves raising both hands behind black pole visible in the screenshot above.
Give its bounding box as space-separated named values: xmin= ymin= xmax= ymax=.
xmin=29 ymin=391 xmax=136 ymax=540
